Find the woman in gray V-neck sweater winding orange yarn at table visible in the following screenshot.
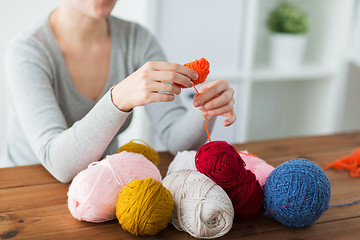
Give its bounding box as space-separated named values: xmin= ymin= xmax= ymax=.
xmin=5 ymin=0 xmax=235 ymax=183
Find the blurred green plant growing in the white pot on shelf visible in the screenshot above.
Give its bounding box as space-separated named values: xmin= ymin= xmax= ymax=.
xmin=266 ymin=2 xmax=309 ymax=33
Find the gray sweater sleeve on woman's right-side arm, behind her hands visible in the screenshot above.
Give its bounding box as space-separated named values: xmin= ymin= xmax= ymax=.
xmin=135 ymin=23 xmax=216 ymax=155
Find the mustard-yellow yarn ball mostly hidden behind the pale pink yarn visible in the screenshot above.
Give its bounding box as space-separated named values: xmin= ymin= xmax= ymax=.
xmin=116 ymin=139 xmax=160 ymax=167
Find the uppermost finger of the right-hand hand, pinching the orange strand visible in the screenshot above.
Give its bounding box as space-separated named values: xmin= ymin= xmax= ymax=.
xmin=194 ymin=80 xmax=233 ymax=107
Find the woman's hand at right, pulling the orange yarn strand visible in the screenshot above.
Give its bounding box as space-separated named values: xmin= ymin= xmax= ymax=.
xmin=193 ymin=80 xmax=236 ymax=126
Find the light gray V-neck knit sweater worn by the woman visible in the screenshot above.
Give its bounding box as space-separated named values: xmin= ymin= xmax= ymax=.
xmin=0 ymin=17 xmax=214 ymax=182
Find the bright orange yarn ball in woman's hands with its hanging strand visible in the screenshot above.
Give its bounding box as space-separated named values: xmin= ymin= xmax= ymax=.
xmin=183 ymin=58 xmax=211 ymax=142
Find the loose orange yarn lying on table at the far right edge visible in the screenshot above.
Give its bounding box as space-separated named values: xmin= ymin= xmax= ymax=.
xmin=323 ymin=148 xmax=360 ymax=177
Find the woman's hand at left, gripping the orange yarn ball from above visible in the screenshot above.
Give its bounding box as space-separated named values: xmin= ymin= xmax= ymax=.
xmin=111 ymin=62 xmax=198 ymax=112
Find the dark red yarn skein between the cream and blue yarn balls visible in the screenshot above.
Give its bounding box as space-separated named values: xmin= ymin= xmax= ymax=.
xmin=195 ymin=141 xmax=263 ymax=218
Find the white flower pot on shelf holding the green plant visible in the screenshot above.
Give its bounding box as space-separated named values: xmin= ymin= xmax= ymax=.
xmin=270 ymin=33 xmax=307 ymax=70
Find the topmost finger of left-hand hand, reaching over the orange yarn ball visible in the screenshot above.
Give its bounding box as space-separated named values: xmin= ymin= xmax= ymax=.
xmin=145 ymin=62 xmax=199 ymax=80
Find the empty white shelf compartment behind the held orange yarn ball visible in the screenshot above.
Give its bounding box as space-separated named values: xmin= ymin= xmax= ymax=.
xmin=157 ymin=0 xmax=244 ymax=77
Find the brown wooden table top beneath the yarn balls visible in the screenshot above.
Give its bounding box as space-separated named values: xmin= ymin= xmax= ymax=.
xmin=0 ymin=132 xmax=360 ymax=240
